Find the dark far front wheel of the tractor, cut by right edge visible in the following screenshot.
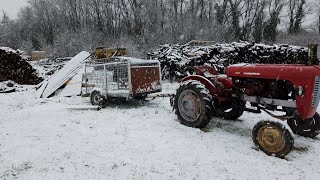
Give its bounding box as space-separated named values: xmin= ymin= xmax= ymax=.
xmin=287 ymin=113 xmax=320 ymax=138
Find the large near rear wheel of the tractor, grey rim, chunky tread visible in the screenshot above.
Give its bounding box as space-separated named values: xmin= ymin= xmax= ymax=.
xmin=174 ymin=80 xmax=213 ymax=128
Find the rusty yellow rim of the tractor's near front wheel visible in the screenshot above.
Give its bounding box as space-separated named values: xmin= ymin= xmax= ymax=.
xmin=257 ymin=125 xmax=285 ymax=153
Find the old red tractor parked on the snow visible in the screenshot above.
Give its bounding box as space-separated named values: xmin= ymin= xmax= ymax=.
xmin=174 ymin=64 xmax=320 ymax=157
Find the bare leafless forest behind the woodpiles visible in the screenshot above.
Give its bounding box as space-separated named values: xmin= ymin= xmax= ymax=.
xmin=0 ymin=0 xmax=320 ymax=57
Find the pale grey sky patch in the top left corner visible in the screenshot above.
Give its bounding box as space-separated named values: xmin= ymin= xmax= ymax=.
xmin=0 ymin=0 xmax=28 ymax=19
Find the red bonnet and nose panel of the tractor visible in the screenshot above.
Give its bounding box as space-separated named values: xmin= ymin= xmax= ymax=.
xmin=226 ymin=64 xmax=320 ymax=119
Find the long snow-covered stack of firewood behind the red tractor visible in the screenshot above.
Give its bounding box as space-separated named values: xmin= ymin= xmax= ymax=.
xmin=148 ymin=42 xmax=308 ymax=78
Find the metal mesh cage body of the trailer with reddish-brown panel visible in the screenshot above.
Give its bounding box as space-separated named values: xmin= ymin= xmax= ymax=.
xmin=82 ymin=60 xmax=161 ymax=98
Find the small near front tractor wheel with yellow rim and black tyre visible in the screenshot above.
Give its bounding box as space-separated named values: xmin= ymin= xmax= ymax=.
xmin=252 ymin=121 xmax=294 ymax=158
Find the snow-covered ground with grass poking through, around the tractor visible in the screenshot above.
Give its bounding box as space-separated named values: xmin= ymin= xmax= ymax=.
xmin=0 ymin=83 xmax=320 ymax=180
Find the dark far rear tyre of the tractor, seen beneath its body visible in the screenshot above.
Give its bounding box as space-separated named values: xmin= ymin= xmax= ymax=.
xmin=215 ymin=101 xmax=245 ymax=120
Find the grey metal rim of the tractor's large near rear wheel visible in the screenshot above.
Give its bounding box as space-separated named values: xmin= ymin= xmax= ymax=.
xmin=178 ymin=90 xmax=201 ymax=122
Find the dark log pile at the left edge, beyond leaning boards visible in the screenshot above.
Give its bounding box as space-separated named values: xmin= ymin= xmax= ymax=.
xmin=0 ymin=47 xmax=43 ymax=85
